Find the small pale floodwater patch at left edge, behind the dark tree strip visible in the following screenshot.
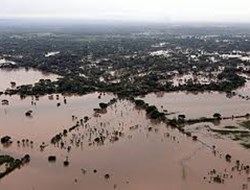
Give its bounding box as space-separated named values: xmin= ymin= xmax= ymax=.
xmin=0 ymin=68 xmax=59 ymax=91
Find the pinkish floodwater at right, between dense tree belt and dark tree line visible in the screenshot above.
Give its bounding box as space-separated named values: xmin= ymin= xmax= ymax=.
xmin=143 ymin=92 xmax=250 ymax=119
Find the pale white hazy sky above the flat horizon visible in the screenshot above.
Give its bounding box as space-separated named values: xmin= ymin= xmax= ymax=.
xmin=0 ymin=0 xmax=250 ymax=22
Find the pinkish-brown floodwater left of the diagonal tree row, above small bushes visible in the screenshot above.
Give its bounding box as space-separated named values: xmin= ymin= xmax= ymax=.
xmin=0 ymin=93 xmax=113 ymax=141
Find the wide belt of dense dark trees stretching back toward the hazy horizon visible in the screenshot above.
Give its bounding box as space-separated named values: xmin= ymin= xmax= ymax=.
xmin=0 ymin=28 xmax=250 ymax=97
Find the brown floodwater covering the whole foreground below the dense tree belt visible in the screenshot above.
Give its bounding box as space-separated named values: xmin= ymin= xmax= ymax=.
xmin=0 ymin=70 xmax=250 ymax=190
